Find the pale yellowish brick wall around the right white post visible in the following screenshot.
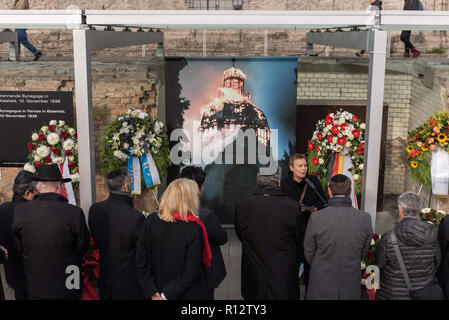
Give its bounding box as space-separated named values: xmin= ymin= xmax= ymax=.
xmin=298 ymin=58 xmax=412 ymax=194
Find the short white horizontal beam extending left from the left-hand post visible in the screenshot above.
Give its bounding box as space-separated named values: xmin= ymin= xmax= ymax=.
xmin=0 ymin=10 xmax=83 ymax=29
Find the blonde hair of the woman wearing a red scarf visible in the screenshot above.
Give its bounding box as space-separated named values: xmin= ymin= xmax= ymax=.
xmin=158 ymin=178 xmax=199 ymax=222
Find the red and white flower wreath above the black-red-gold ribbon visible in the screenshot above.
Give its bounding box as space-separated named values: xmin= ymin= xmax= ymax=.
xmin=307 ymin=109 xmax=365 ymax=194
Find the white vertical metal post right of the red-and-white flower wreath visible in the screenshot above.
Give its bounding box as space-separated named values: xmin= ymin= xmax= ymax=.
xmin=362 ymin=29 xmax=387 ymax=230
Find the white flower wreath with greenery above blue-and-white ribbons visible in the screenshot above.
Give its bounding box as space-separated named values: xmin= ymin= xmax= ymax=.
xmin=101 ymin=109 xmax=171 ymax=191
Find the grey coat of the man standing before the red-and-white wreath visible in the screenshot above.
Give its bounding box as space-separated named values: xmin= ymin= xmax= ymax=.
xmin=304 ymin=196 xmax=373 ymax=300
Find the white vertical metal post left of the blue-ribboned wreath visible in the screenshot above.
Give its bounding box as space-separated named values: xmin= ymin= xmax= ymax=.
xmin=73 ymin=30 xmax=96 ymax=220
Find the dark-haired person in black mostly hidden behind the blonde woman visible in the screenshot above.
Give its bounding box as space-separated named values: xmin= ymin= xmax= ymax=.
xmin=180 ymin=166 xmax=228 ymax=300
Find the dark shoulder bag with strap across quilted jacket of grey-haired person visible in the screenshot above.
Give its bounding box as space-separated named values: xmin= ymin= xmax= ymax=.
xmin=391 ymin=230 xmax=444 ymax=300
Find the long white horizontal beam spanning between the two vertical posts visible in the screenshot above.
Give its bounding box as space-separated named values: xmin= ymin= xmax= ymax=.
xmin=86 ymin=10 xmax=375 ymax=30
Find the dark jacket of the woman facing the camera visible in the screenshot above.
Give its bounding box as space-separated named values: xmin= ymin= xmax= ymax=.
xmin=281 ymin=171 xmax=327 ymax=223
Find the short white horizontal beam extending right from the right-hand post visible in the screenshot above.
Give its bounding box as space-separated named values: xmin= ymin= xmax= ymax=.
xmin=380 ymin=10 xmax=449 ymax=30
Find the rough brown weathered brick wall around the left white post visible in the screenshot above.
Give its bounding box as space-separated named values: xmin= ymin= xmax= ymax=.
xmin=0 ymin=59 xmax=162 ymax=211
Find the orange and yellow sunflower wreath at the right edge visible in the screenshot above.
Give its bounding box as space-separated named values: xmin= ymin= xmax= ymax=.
xmin=405 ymin=111 xmax=449 ymax=188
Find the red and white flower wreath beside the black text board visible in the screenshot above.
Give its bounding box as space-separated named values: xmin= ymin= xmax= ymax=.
xmin=24 ymin=120 xmax=79 ymax=189
